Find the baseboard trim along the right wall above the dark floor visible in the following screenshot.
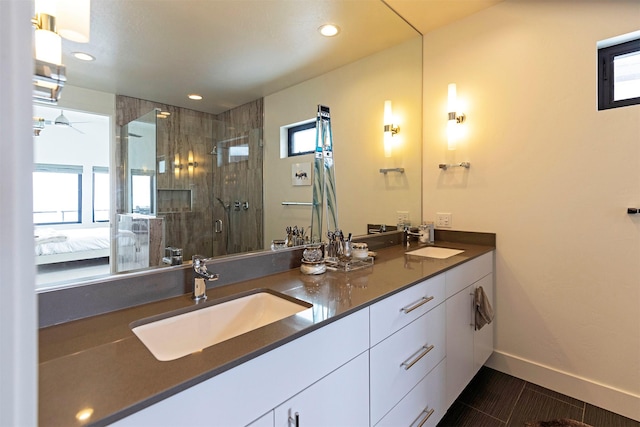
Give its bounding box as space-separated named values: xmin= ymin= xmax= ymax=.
xmin=486 ymin=351 xmax=640 ymax=421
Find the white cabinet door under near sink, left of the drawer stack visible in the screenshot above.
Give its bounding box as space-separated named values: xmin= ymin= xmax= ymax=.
xmin=275 ymin=352 xmax=369 ymax=427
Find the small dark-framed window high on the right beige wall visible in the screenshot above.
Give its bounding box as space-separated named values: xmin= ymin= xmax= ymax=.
xmin=598 ymin=39 xmax=640 ymax=110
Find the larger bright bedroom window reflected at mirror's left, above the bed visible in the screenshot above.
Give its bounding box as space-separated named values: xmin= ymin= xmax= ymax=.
xmin=33 ymin=163 xmax=82 ymax=224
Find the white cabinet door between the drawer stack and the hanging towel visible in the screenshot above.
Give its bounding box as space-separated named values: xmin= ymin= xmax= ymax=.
xmin=445 ymin=286 xmax=474 ymax=407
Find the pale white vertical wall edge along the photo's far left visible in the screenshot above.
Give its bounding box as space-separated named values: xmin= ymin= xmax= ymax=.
xmin=0 ymin=0 xmax=38 ymax=426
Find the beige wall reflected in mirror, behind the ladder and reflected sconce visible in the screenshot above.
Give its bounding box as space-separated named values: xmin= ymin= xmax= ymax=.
xmin=264 ymin=37 xmax=422 ymax=246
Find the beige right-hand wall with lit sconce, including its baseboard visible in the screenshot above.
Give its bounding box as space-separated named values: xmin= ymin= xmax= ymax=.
xmin=423 ymin=0 xmax=640 ymax=420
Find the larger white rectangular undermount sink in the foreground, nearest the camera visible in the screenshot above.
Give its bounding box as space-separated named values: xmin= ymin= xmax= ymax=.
xmin=130 ymin=289 xmax=312 ymax=361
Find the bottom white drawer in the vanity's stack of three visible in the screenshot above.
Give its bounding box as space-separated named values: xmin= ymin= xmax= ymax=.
xmin=376 ymin=359 xmax=447 ymax=427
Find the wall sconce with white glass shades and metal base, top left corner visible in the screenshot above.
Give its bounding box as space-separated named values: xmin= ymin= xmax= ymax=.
xmin=31 ymin=0 xmax=91 ymax=103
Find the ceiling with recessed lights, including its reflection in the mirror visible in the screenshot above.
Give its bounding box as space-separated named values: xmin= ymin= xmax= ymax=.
xmin=56 ymin=0 xmax=500 ymax=114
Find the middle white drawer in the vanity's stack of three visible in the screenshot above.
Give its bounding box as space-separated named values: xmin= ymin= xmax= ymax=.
xmin=369 ymin=304 xmax=445 ymax=424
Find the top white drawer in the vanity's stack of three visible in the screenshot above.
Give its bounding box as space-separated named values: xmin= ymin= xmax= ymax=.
xmin=369 ymin=274 xmax=445 ymax=346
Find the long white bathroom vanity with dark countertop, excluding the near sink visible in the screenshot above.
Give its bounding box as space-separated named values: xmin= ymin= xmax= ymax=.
xmin=39 ymin=236 xmax=495 ymax=426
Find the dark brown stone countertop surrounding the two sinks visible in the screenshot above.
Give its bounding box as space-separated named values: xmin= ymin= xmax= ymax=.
xmin=38 ymin=240 xmax=495 ymax=426
